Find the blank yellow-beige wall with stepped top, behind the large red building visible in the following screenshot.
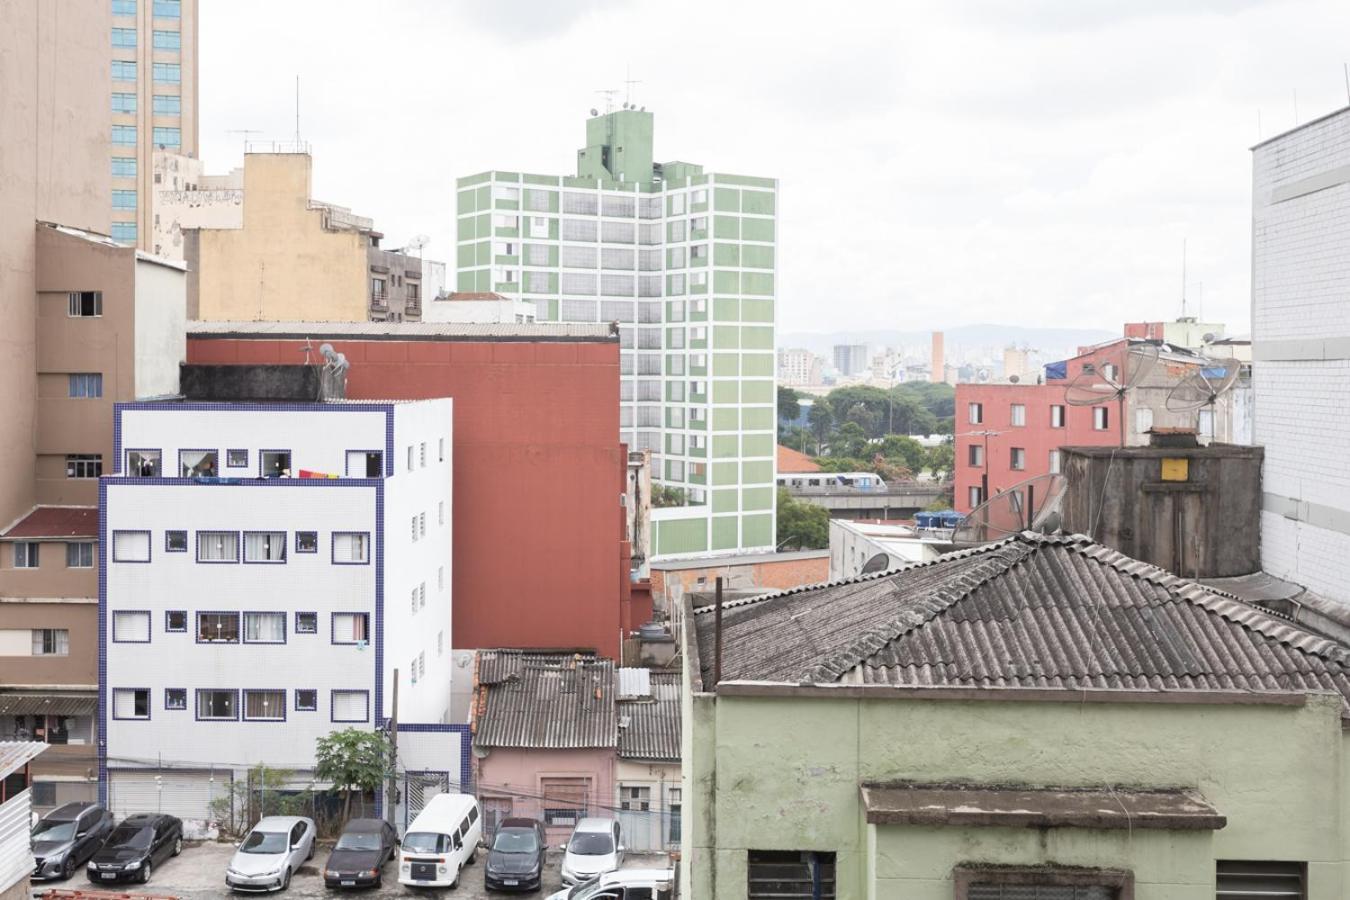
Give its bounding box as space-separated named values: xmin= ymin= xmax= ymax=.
xmin=186 ymin=154 xmax=370 ymax=321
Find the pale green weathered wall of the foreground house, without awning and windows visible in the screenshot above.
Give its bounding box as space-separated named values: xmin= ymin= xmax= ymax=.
xmin=684 ymin=692 xmax=1350 ymax=900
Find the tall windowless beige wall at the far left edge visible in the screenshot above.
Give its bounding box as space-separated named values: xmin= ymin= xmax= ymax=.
xmin=0 ymin=0 xmax=112 ymax=522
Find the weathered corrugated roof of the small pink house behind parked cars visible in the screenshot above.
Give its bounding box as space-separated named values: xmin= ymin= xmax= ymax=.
xmin=474 ymin=650 xmax=618 ymax=749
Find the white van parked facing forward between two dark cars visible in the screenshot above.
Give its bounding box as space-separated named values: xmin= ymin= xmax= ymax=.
xmin=398 ymin=793 xmax=483 ymax=888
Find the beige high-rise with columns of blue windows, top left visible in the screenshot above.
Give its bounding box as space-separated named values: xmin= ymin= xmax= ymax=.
xmin=110 ymin=0 xmax=197 ymax=251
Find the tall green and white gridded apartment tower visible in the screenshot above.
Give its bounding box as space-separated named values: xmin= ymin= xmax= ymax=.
xmin=456 ymin=109 xmax=778 ymax=557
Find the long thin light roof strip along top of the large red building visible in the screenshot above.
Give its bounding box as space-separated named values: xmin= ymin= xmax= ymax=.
xmin=188 ymin=321 xmax=618 ymax=343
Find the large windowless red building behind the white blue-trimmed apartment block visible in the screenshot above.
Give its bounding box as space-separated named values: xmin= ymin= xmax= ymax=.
xmin=188 ymin=322 xmax=629 ymax=658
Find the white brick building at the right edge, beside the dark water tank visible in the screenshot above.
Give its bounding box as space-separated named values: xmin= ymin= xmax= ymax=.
xmin=1251 ymin=108 xmax=1350 ymax=603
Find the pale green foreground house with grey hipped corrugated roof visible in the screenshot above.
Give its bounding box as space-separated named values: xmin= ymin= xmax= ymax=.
xmin=682 ymin=534 xmax=1350 ymax=900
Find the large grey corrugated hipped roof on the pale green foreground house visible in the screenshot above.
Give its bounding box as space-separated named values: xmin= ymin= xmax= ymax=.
xmin=695 ymin=533 xmax=1350 ymax=710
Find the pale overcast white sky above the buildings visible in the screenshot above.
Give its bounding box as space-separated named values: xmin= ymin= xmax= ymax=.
xmin=200 ymin=0 xmax=1350 ymax=332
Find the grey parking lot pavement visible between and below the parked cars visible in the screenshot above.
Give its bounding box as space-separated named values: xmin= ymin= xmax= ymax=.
xmin=32 ymin=843 xmax=670 ymax=900
